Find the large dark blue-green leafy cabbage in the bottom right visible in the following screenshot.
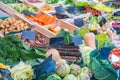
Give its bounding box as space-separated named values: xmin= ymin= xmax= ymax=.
xmin=89 ymin=50 xmax=117 ymax=80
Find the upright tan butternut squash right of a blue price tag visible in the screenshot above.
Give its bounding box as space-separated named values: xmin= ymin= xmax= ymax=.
xmin=83 ymin=33 xmax=96 ymax=49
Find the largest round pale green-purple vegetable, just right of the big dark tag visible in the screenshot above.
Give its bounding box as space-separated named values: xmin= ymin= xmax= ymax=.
xmin=56 ymin=62 xmax=70 ymax=77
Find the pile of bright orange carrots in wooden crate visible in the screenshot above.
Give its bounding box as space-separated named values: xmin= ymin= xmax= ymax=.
xmin=25 ymin=12 xmax=57 ymax=25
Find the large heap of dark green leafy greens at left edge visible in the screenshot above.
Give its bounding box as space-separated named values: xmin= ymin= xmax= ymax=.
xmin=0 ymin=35 xmax=46 ymax=66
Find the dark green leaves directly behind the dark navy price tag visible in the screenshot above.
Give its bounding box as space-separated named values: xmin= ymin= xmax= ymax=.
xmin=56 ymin=29 xmax=72 ymax=44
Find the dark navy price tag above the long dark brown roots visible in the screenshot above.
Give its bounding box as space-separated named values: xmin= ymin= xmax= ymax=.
xmin=49 ymin=37 xmax=64 ymax=46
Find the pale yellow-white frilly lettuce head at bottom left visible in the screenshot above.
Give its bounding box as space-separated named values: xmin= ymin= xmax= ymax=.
xmin=11 ymin=62 xmax=33 ymax=80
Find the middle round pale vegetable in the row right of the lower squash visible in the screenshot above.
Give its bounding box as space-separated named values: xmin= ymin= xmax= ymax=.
xmin=70 ymin=64 xmax=81 ymax=76
